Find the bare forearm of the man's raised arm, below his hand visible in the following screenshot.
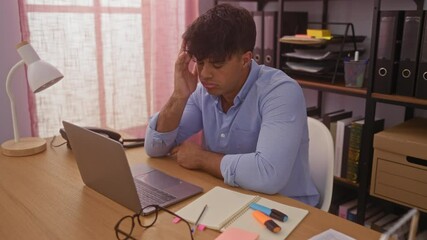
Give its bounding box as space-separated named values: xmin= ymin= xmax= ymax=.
xmin=156 ymin=95 xmax=188 ymax=132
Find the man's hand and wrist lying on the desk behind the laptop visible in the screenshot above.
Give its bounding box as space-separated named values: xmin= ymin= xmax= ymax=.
xmin=171 ymin=141 xmax=224 ymax=178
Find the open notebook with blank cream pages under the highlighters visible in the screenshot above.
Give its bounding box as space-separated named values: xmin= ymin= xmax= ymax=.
xmin=176 ymin=187 xmax=308 ymax=240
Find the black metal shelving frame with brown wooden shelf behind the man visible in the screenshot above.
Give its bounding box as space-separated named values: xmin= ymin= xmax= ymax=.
xmin=215 ymin=0 xmax=427 ymax=227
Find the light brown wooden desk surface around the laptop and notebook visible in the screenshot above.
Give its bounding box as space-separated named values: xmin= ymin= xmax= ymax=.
xmin=0 ymin=138 xmax=380 ymax=239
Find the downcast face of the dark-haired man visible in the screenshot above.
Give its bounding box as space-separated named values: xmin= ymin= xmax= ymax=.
xmin=196 ymin=52 xmax=251 ymax=99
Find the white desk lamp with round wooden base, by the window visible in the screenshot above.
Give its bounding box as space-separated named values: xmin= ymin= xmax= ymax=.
xmin=1 ymin=41 xmax=64 ymax=157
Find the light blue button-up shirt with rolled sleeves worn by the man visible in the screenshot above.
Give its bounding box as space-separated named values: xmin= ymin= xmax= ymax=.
xmin=145 ymin=60 xmax=319 ymax=206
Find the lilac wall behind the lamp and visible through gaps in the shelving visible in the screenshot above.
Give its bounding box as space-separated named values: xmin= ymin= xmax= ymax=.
xmin=0 ymin=0 xmax=427 ymax=143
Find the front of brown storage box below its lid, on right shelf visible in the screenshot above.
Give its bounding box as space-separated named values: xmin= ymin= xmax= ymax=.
xmin=371 ymin=149 xmax=427 ymax=212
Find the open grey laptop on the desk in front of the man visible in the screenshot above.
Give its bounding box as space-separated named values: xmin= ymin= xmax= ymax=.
xmin=62 ymin=121 xmax=203 ymax=214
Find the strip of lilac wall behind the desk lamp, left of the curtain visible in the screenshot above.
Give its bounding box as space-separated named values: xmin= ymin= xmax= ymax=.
xmin=0 ymin=0 xmax=31 ymax=143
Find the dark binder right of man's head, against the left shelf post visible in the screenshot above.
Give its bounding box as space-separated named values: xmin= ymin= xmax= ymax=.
xmin=263 ymin=11 xmax=278 ymax=67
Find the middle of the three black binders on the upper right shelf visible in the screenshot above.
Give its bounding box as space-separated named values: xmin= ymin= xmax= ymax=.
xmin=396 ymin=11 xmax=424 ymax=96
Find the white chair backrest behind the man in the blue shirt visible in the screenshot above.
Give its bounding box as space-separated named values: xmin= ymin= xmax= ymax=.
xmin=307 ymin=117 xmax=335 ymax=212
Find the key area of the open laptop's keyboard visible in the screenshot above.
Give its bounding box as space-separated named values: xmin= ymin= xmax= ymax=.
xmin=135 ymin=179 xmax=176 ymax=206
